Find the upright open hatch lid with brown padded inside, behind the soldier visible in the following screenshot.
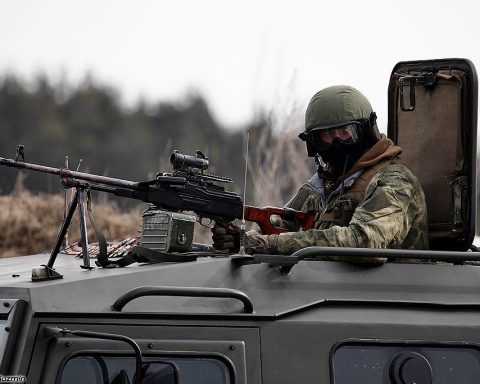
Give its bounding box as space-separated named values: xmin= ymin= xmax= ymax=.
xmin=388 ymin=59 xmax=478 ymax=251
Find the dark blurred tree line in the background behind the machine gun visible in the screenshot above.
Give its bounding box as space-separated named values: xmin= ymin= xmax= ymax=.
xmin=0 ymin=75 xmax=282 ymax=202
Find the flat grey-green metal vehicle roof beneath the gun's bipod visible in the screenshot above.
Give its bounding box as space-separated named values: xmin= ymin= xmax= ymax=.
xmin=0 ymin=254 xmax=480 ymax=317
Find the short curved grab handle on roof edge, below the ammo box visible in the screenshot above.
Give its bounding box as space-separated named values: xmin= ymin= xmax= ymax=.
xmin=112 ymin=286 xmax=254 ymax=313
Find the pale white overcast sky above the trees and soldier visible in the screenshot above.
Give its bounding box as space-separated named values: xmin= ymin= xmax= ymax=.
xmin=0 ymin=0 xmax=480 ymax=130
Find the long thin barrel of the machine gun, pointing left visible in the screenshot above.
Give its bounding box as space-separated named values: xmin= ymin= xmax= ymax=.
xmin=0 ymin=157 xmax=140 ymax=190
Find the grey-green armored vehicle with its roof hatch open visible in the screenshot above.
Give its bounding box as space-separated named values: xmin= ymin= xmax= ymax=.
xmin=0 ymin=59 xmax=480 ymax=384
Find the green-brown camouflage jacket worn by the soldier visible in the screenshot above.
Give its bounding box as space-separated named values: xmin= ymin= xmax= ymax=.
xmin=251 ymin=138 xmax=428 ymax=262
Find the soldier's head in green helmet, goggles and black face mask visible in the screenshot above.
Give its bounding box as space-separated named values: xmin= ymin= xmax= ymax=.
xmin=299 ymin=85 xmax=380 ymax=177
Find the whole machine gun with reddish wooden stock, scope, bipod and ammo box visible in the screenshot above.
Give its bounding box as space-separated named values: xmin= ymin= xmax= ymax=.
xmin=0 ymin=145 xmax=314 ymax=280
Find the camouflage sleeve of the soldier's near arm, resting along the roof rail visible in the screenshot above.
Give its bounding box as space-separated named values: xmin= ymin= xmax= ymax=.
xmin=262 ymin=166 xmax=417 ymax=260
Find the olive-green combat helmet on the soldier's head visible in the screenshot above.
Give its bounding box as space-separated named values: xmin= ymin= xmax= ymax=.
xmin=299 ymin=85 xmax=380 ymax=157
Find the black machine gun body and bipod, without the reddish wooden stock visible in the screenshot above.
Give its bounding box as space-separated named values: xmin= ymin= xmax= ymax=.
xmin=0 ymin=146 xmax=243 ymax=279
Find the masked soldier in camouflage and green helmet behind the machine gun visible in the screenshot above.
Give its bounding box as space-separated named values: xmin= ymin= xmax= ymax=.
xmin=212 ymin=86 xmax=428 ymax=263
